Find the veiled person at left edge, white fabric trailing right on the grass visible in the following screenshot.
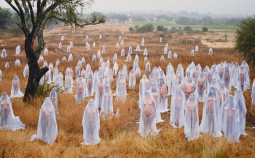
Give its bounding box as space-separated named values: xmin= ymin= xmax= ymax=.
xmin=0 ymin=92 xmax=25 ymax=131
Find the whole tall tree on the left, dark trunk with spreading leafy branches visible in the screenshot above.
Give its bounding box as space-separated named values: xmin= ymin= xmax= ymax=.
xmin=5 ymin=0 xmax=105 ymax=102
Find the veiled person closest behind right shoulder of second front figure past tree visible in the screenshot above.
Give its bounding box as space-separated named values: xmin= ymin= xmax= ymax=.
xmin=101 ymin=83 xmax=113 ymax=116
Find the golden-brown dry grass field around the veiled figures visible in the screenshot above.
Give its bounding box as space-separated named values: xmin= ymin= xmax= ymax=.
xmin=0 ymin=24 xmax=255 ymax=158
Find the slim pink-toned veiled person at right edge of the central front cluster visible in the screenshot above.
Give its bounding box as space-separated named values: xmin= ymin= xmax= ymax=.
xmin=158 ymin=78 xmax=168 ymax=112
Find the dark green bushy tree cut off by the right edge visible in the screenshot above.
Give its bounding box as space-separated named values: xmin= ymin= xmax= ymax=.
xmin=235 ymin=16 xmax=255 ymax=66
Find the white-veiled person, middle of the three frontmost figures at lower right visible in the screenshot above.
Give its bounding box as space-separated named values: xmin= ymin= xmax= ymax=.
xmin=200 ymin=87 xmax=222 ymax=137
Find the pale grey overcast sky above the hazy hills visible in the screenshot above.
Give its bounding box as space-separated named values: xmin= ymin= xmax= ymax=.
xmin=0 ymin=0 xmax=255 ymax=15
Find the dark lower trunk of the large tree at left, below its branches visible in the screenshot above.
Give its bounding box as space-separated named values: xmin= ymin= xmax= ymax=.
xmin=23 ymin=35 xmax=49 ymax=102
